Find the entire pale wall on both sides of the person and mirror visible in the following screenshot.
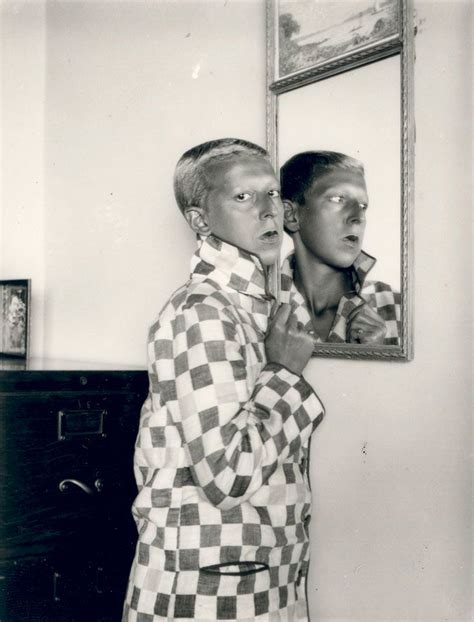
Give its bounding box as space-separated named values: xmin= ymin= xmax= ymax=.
xmin=0 ymin=0 xmax=472 ymax=622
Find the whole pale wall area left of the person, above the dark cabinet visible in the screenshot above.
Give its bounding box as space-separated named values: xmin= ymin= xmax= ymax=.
xmin=0 ymin=0 xmax=265 ymax=365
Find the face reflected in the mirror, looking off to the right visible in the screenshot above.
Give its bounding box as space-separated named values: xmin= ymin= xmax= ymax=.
xmin=297 ymin=169 xmax=368 ymax=269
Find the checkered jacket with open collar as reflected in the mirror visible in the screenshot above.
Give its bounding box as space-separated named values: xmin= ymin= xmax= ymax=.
xmin=281 ymin=251 xmax=400 ymax=345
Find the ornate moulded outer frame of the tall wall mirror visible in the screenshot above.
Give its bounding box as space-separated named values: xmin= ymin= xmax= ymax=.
xmin=266 ymin=0 xmax=415 ymax=361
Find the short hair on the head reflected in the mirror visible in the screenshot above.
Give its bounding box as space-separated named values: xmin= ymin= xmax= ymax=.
xmin=280 ymin=151 xmax=364 ymax=205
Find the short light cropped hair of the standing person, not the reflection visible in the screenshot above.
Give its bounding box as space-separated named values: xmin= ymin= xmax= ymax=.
xmin=174 ymin=138 xmax=270 ymax=213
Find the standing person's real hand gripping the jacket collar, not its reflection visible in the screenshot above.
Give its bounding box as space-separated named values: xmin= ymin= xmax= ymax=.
xmin=265 ymin=304 xmax=314 ymax=376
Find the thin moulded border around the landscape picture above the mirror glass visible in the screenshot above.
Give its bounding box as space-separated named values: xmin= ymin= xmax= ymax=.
xmin=267 ymin=0 xmax=403 ymax=93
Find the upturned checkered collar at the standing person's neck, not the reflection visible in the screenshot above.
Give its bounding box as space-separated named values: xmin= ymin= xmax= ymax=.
xmin=191 ymin=235 xmax=270 ymax=299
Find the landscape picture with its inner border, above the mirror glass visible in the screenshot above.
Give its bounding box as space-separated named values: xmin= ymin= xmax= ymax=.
xmin=267 ymin=0 xmax=402 ymax=88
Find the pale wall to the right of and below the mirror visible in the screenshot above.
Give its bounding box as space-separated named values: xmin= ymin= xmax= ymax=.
xmin=307 ymin=2 xmax=473 ymax=622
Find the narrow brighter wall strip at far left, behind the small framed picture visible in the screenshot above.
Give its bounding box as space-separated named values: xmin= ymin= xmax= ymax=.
xmin=0 ymin=0 xmax=46 ymax=353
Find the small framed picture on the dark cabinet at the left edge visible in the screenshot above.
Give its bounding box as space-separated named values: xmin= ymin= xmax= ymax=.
xmin=0 ymin=279 xmax=31 ymax=359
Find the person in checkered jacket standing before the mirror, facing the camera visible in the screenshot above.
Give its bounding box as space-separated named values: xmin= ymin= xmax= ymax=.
xmin=123 ymin=138 xmax=323 ymax=622
